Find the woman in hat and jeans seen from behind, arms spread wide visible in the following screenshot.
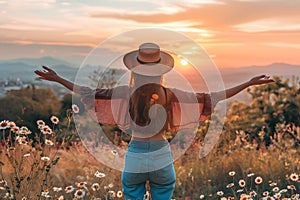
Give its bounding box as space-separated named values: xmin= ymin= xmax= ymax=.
xmin=35 ymin=43 xmax=273 ymax=200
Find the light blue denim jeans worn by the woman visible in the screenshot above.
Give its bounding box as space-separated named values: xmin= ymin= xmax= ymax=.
xmin=122 ymin=140 xmax=176 ymax=200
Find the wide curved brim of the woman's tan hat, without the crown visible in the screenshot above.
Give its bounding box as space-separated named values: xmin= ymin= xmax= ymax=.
xmin=123 ymin=50 xmax=174 ymax=76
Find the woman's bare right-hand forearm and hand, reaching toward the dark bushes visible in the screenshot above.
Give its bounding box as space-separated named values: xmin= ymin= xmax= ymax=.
xmin=215 ymin=75 xmax=274 ymax=101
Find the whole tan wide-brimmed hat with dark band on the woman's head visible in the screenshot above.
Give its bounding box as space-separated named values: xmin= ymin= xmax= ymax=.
xmin=123 ymin=43 xmax=174 ymax=76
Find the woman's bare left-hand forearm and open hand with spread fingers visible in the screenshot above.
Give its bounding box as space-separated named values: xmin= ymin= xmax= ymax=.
xmin=34 ymin=66 xmax=81 ymax=94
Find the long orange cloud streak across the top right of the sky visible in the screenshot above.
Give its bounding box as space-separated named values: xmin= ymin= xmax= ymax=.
xmin=90 ymin=0 xmax=300 ymax=30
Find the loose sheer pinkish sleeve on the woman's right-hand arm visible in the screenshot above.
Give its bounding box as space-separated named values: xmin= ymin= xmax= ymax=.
xmin=167 ymin=89 xmax=216 ymax=132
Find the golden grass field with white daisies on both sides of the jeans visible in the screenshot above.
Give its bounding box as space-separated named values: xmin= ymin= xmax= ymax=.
xmin=0 ymin=114 xmax=300 ymax=199
